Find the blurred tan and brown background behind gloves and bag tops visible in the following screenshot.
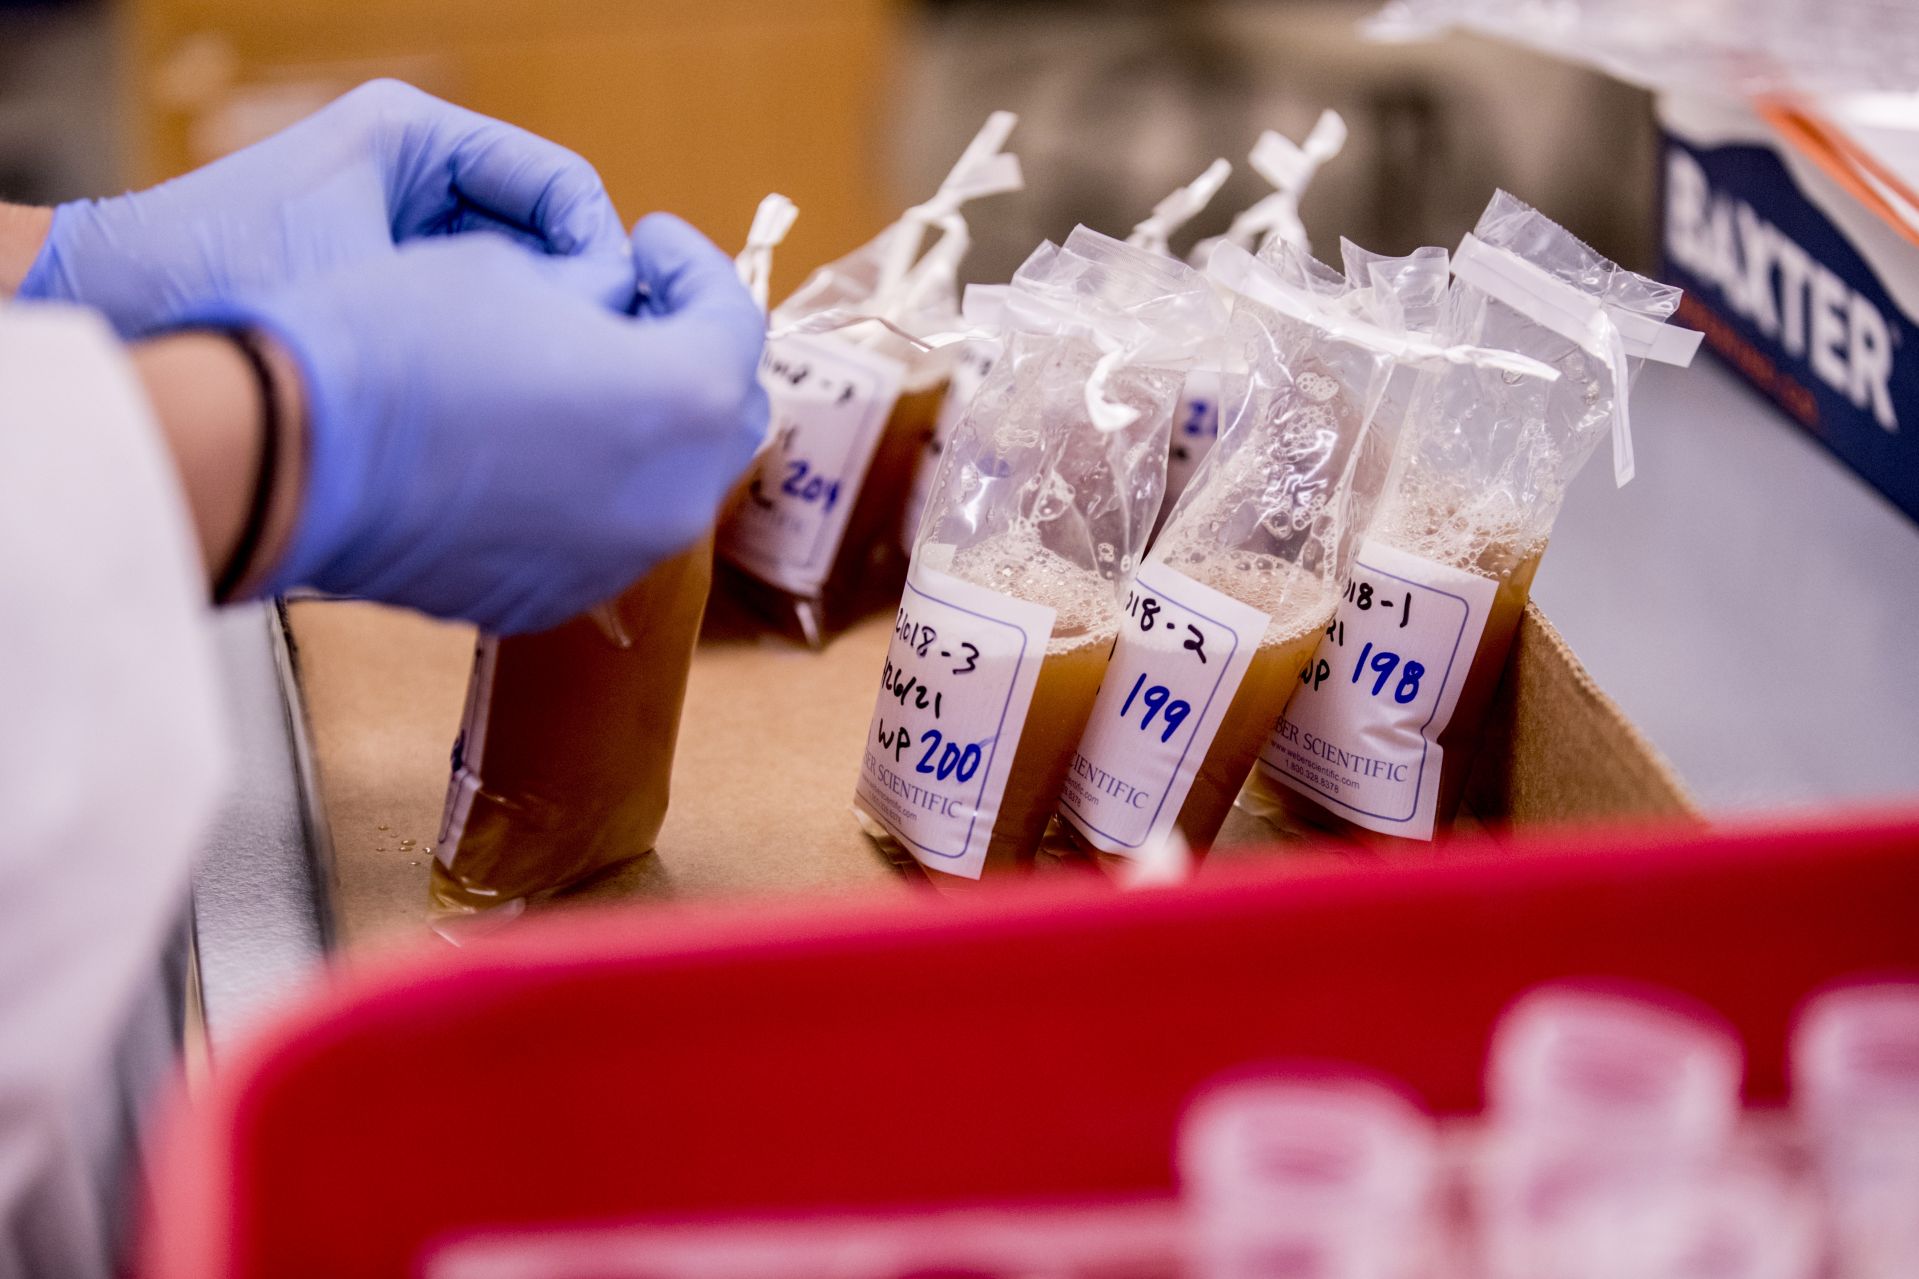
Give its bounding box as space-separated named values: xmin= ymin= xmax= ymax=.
xmin=0 ymin=0 xmax=1656 ymax=298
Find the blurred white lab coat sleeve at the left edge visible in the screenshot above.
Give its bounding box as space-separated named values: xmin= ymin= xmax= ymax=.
xmin=0 ymin=305 xmax=226 ymax=1275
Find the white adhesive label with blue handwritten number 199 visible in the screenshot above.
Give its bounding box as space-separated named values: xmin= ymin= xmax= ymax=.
xmin=1059 ymin=563 xmax=1270 ymax=855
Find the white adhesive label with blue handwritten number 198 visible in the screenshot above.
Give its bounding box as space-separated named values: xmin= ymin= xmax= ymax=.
xmin=1259 ymin=542 xmax=1499 ymax=839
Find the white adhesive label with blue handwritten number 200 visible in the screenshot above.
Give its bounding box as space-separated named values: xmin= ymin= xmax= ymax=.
xmin=856 ymin=557 xmax=1054 ymax=880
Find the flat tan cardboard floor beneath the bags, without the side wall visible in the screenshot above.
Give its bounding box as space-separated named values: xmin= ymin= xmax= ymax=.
xmin=274 ymin=599 xmax=1335 ymax=951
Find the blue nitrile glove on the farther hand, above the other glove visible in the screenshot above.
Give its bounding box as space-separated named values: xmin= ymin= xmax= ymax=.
xmin=19 ymin=81 xmax=626 ymax=336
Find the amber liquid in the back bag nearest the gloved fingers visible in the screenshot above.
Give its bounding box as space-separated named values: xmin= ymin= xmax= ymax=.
xmin=727 ymin=382 xmax=946 ymax=645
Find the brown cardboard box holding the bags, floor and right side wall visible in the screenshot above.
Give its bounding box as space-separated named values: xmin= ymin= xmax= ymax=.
xmin=288 ymin=595 xmax=1696 ymax=947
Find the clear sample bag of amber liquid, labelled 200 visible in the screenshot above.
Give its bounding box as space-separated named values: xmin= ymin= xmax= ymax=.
xmin=854 ymin=227 xmax=1222 ymax=880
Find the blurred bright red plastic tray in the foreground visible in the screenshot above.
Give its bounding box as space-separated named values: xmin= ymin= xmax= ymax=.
xmin=146 ymin=816 xmax=1919 ymax=1279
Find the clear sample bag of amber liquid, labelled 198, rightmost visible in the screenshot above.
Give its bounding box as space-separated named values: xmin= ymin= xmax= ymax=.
xmin=1247 ymin=192 xmax=1698 ymax=839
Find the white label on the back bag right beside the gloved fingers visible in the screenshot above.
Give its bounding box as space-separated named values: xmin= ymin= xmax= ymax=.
xmin=720 ymin=334 xmax=906 ymax=595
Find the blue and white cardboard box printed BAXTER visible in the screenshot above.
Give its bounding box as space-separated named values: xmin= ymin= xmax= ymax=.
xmin=1660 ymin=96 xmax=1919 ymax=519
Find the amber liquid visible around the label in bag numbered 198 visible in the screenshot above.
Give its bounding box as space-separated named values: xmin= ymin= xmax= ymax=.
xmin=1251 ymin=543 xmax=1545 ymax=845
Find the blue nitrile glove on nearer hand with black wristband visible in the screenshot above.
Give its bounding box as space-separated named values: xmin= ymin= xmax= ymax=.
xmin=182 ymin=213 xmax=768 ymax=634
